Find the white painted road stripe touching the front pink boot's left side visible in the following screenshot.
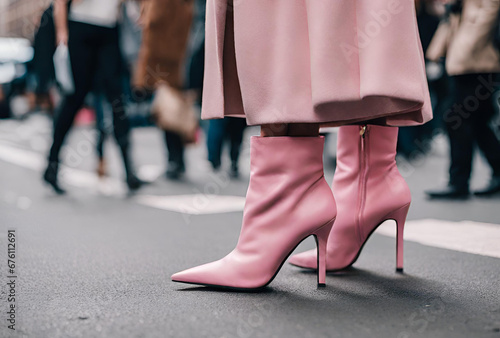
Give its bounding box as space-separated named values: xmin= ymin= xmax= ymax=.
xmin=136 ymin=194 xmax=245 ymax=215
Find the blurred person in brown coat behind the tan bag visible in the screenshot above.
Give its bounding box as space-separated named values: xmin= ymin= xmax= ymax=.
xmin=133 ymin=0 xmax=193 ymax=179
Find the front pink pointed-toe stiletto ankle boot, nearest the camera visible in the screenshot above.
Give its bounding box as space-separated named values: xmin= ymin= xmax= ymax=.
xmin=172 ymin=137 xmax=337 ymax=289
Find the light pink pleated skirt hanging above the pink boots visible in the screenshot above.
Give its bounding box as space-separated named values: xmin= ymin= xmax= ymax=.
xmin=202 ymin=0 xmax=432 ymax=126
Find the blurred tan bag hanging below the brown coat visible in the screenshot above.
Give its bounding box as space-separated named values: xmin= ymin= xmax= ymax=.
xmin=151 ymin=83 xmax=198 ymax=143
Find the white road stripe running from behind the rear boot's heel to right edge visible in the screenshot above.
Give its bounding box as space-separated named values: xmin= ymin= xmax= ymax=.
xmin=376 ymin=219 xmax=500 ymax=258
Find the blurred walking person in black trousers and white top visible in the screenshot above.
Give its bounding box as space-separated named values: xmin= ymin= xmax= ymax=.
xmin=44 ymin=0 xmax=142 ymax=193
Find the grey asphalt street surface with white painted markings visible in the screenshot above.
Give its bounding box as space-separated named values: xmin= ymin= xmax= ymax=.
xmin=0 ymin=115 xmax=500 ymax=338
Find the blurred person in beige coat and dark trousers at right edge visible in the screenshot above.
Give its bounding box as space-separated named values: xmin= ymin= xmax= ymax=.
xmin=427 ymin=0 xmax=500 ymax=199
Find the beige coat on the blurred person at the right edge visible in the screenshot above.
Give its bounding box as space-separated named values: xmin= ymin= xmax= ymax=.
xmin=427 ymin=0 xmax=500 ymax=75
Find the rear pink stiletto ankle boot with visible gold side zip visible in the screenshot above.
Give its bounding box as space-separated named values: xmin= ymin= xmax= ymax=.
xmin=290 ymin=125 xmax=411 ymax=272
